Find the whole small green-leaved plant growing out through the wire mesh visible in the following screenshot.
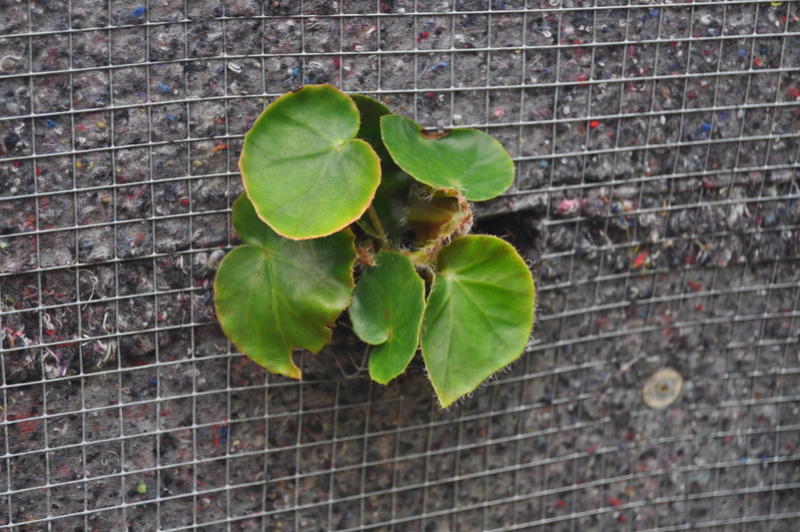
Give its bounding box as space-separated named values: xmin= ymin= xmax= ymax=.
xmin=214 ymin=85 xmax=535 ymax=407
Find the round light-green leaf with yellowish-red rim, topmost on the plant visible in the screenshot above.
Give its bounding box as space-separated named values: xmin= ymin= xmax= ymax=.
xmin=239 ymin=85 xmax=381 ymax=240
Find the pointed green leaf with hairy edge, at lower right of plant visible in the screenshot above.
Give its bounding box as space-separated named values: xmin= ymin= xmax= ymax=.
xmin=421 ymin=235 xmax=536 ymax=407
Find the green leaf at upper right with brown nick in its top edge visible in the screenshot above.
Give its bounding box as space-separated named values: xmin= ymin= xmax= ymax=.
xmin=381 ymin=115 xmax=514 ymax=201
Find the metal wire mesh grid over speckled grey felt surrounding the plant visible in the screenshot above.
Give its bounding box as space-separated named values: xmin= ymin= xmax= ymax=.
xmin=0 ymin=0 xmax=800 ymax=531
